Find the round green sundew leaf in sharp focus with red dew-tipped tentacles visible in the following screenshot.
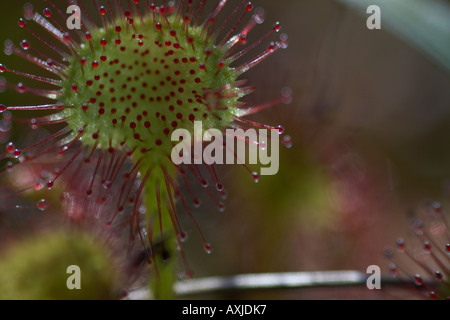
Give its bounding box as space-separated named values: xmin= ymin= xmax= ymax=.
xmin=0 ymin=0 xmax=291 ymax=298
